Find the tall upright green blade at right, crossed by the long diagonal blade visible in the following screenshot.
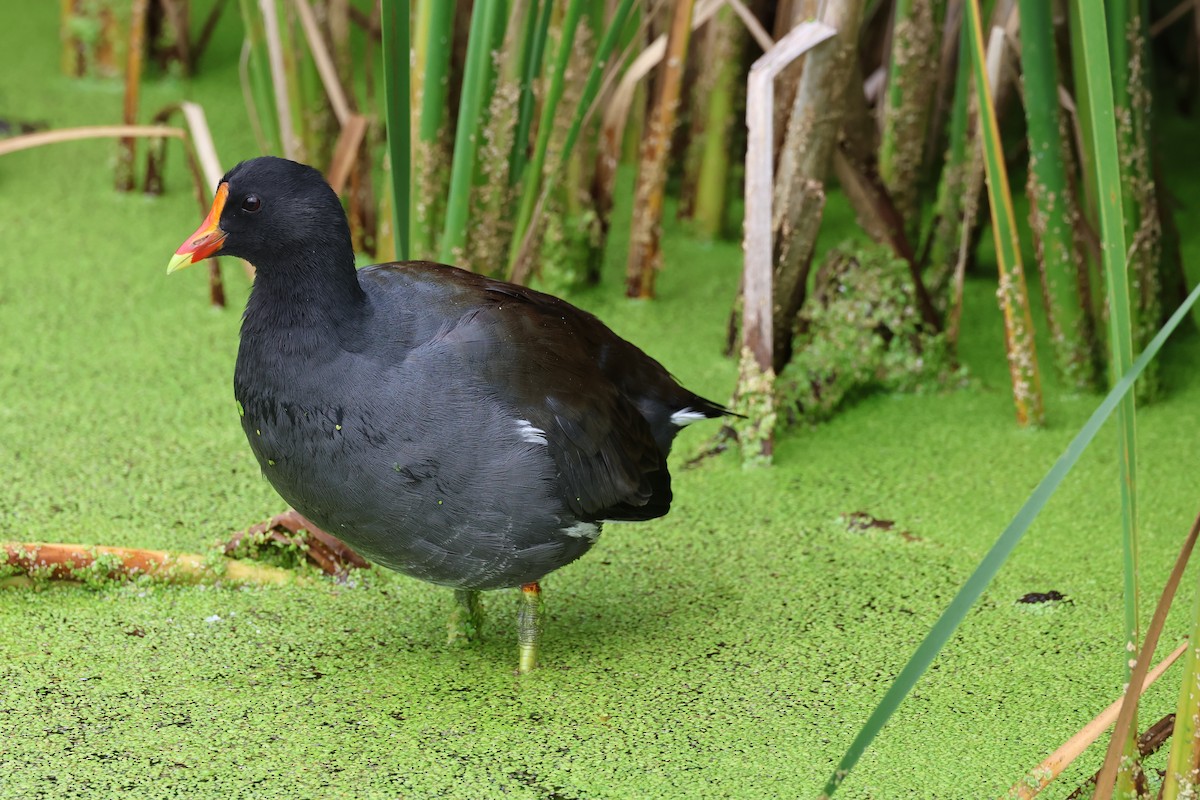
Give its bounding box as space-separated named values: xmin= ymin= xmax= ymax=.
xmin=1072 ymin=0 xmax=1139 ymax=800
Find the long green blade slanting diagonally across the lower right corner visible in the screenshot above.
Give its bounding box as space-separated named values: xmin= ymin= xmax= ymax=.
xmin=822 ymin=273 xmax=1200 ymax=798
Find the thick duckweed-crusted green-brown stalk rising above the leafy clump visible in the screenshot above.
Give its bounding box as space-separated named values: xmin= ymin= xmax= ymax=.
xmin=880 ymin=0 xmax=946 ymax=239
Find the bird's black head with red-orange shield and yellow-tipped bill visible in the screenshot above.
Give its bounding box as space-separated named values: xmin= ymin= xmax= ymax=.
xmin=167 ymin=156 xmax=353 ymax=273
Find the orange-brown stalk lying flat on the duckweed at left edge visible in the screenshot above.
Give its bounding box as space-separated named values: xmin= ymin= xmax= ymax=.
xmin=0 ymin=542 xmax=298 ymax=585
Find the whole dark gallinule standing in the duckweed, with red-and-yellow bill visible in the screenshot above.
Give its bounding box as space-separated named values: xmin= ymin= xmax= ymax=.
xmin=167 ymin=157 xmax=728 ymax=672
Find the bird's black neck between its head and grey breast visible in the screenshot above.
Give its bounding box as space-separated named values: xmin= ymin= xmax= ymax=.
xmin=242 ymin=248 xmax=366 ymax=335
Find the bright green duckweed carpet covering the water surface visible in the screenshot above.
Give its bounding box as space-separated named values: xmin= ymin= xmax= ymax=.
xmin=7 ymin=0 xmax=1200 ymax=798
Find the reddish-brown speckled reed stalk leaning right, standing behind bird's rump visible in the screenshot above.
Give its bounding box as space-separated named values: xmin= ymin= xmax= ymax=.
xmin=625 ymin=0 xmax=696 ymax=300
